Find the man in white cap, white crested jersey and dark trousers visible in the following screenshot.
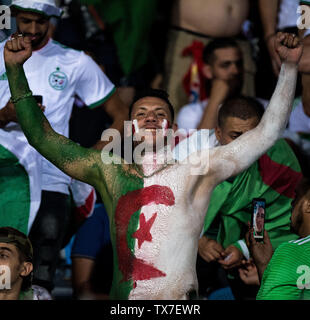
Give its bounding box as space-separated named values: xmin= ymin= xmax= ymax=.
xmin=0 ymin=0 xmax=128 ymax=291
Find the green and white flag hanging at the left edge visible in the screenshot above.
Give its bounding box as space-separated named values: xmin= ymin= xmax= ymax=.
xmin=0 ymin=125 xmax=41 ymax=234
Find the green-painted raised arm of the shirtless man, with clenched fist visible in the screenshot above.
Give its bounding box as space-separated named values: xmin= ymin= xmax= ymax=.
xmin=4 ymin=36 xmax=101 ymax=186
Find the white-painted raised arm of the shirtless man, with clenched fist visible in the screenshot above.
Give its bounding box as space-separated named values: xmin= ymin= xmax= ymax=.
xmin=210 ymin=33 xmax=302 ymax=183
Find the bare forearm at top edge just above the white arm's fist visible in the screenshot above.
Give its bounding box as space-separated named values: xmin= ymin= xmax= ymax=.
xmin=259 ymin=0 xmax=278 ymax=39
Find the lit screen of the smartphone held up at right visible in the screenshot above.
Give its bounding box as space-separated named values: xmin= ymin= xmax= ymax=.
xmin=252 ymin=198 xmax=266 ymax=240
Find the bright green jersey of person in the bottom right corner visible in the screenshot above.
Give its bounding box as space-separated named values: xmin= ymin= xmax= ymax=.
xmin=256 ymin=235 xmax=310 ymax=300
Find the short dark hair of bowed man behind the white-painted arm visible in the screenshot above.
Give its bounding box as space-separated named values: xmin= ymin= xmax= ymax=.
xmin=218 ymin=96 xmax=265 ymax=128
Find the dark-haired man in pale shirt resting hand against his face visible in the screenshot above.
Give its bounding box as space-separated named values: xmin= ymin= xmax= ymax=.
xmin=177 ymin=38 xmax=243 ymax=130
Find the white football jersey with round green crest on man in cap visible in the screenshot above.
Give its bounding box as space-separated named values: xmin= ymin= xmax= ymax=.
xmin=0 ymin=39 xmax=115 ymax=194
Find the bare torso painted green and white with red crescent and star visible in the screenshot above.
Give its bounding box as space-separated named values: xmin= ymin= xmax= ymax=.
xmin=98 ymin=131 xmax=212 ymax=299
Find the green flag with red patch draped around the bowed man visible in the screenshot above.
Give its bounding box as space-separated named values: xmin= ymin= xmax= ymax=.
xmin=204 ymin=139 xmax=302 ymax=248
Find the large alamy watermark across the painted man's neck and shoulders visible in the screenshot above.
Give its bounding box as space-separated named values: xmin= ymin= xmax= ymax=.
xmin=101 ymin=121 xmax=210 ymax=175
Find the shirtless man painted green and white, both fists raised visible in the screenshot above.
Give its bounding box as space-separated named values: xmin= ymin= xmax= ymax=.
xmin=4 ymin=34 xmax=302 ymax=299
